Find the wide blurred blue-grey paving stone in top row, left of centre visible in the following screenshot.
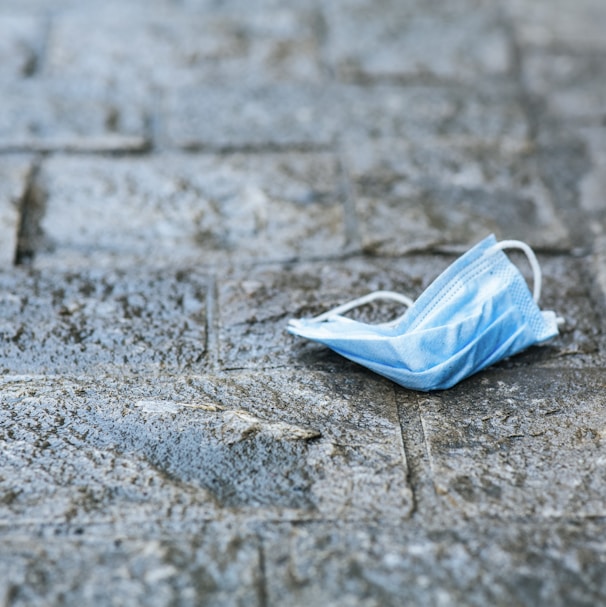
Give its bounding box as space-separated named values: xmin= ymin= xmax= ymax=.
xmin=46 ymin=7 xmax=322 ymax=90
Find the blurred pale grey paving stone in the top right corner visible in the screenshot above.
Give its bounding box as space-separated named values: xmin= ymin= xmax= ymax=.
xmin=503 ymin=0 xmax=606 ymax=50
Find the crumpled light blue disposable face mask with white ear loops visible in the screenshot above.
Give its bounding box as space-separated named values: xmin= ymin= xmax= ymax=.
xmin=288 ymin=236 xmax=563 ymax=391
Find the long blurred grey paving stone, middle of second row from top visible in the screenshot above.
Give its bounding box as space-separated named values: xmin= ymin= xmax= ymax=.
xmin=163 ymin=84 xmax=528 ymax=150
